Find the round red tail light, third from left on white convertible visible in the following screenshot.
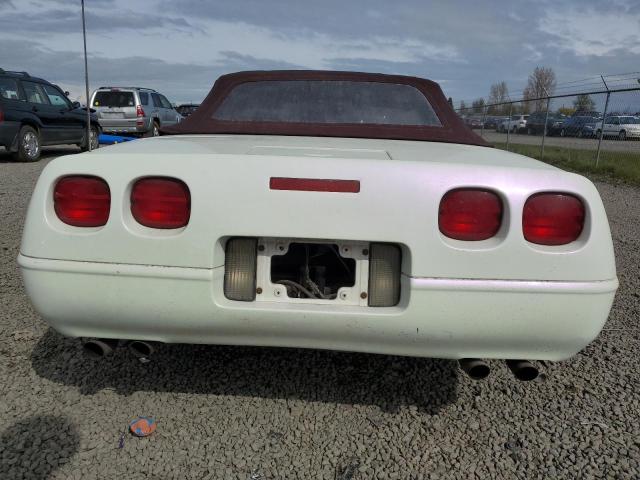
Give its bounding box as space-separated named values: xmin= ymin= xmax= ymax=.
xmin=438 ymin=188 xmax=502 ymax=241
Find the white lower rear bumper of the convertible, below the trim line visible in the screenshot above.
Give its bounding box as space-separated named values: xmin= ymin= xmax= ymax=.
xmin=18 ymin=254 xmax=618 ymax=360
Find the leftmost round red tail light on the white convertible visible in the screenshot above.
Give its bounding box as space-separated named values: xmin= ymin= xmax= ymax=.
xmin=53 ymin=176 xmax=111 ymax=227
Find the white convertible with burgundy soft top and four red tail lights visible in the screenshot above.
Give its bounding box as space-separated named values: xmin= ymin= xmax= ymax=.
xmin=18 ymin=71 xmax=618 ymax=379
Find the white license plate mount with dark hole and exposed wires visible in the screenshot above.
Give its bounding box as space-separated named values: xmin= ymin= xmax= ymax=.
xmin=256 ymin=238 xmax=370 ymax=306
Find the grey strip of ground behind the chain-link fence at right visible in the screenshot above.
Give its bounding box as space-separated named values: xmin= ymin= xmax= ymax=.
xmin=474 ymin=129 xmax=640 ymax=154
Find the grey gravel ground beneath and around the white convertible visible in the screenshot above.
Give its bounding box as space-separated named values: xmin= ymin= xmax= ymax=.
xmin=0 ymin=151 xmax=640 ymax=480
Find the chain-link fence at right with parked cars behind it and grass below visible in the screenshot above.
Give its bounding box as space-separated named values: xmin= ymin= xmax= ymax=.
xmin=456 ymin=77 xmax=640 ymax=181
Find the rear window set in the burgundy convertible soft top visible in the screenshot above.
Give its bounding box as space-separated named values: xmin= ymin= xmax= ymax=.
xmin=213 ymin=80 xmax=442 ymax=127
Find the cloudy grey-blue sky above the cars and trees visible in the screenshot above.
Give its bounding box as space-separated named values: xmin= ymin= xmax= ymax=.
xmin=0 ymin=0 xmax=640 ymax=103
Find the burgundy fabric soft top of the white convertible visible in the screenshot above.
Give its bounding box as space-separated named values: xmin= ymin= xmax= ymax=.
xmin=161 ymin=70 xmax=489 ymax=146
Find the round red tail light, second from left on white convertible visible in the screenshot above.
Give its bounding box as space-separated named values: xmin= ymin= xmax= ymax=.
xmin=131 ymin=177 xmax=191 ymax=229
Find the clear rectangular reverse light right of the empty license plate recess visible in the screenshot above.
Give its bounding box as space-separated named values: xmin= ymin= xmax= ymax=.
xmin=369 ymin=243 xmax=400 ymax=307
